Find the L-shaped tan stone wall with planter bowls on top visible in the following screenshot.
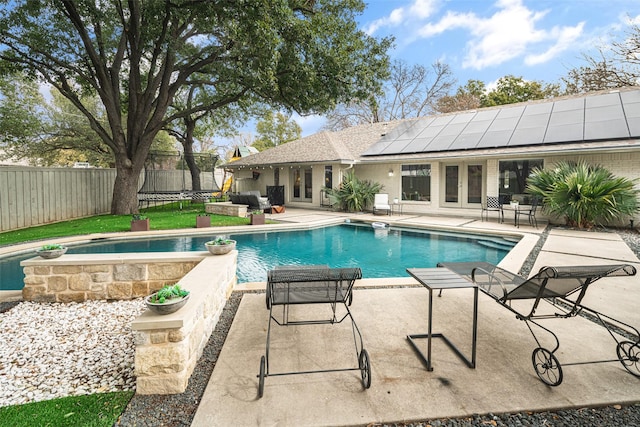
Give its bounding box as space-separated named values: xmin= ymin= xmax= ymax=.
xmin=21 ymin=251 xmax=238 ymax=394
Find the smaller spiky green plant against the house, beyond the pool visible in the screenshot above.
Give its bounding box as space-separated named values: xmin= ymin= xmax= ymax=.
xmin=326 ymin=171 xmax=382 ymax=212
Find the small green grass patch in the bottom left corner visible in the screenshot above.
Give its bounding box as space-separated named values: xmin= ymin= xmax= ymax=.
xmin=0 ymin=391 xmax=134 ymax=427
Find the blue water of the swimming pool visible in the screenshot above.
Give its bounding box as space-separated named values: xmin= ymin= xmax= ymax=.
xmin=0 ymin=223 xmax=516 ymax=290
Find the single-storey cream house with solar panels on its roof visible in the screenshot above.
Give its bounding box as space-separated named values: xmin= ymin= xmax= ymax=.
xmin=225 ymin=87 xmax=640 ymax=224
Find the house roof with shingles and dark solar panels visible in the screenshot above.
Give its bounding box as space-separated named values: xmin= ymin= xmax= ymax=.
xmin=225 ymin=87 xmax=640 ymax=168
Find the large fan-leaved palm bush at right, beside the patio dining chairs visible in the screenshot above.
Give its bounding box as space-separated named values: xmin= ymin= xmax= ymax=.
xmin=527 ymin=162 xmax=640 ymax=228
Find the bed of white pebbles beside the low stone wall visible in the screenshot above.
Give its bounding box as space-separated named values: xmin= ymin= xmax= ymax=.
xmin=0 ymin=299 xmax=145 ymax=407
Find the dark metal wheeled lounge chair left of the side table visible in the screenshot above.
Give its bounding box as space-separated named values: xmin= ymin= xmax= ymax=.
xmin=258 ymin=265 xmax=371 ymax=397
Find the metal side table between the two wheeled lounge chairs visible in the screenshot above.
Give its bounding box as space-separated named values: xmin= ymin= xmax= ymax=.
xmin=407 ymin=268 xmax=478 ymax=371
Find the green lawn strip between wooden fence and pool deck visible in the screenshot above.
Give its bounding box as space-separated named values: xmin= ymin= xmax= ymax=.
xmin=0 ymin=203 xmax=249 ymax=246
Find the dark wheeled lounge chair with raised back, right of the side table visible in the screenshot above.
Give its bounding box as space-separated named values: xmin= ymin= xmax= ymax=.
xmin=438 ymin=262 xmax=640 ymax=386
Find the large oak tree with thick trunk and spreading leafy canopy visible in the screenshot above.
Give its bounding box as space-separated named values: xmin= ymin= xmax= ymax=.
xmin=0 ymin=0 xmax=390 ymax=214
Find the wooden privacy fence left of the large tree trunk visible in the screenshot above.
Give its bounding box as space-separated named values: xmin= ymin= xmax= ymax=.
xmin=0 ymin=166 xmax=116 ymax=234
